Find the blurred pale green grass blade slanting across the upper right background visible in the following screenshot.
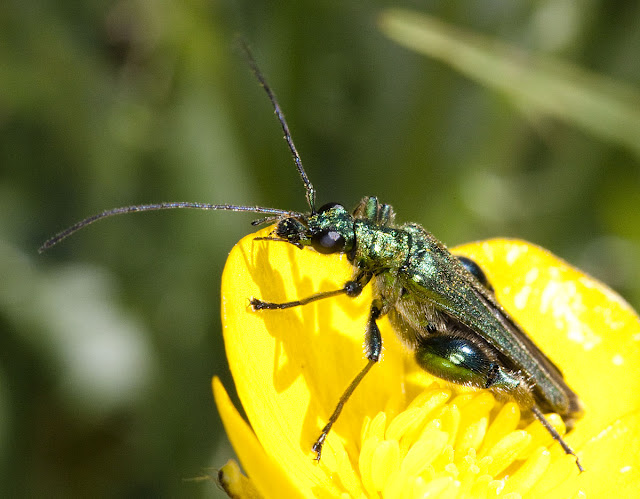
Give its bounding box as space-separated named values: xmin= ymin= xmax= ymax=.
xmin=380 ymin=9 xmax=640 ymax=156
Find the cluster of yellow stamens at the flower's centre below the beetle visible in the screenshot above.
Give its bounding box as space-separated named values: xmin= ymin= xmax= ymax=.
xmin=322 ymin=382 xmax=577 ymax=498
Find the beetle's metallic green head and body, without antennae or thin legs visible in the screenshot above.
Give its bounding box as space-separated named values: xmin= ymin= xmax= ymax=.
xmin=276 ymin=197 xmax=581 ymax=426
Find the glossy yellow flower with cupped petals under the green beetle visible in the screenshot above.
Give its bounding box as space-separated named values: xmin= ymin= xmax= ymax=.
xmin=213 ymin=229 xmax=640 ymax=499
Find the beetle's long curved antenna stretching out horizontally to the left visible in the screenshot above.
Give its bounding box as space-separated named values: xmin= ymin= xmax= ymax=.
xmin=38 ymin=201 xmax=303 ymax=253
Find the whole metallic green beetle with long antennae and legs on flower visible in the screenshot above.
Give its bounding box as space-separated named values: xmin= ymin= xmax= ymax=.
xmin=40 ymin=44 xmax=583 ymax=471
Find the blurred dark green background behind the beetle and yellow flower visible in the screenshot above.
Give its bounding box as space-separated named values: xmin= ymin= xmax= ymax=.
xmin=0 ymin=0 xmax=640 ymax=497
